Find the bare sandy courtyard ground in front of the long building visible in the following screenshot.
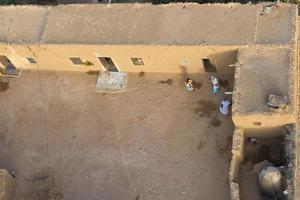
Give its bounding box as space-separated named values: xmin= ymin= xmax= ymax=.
xmin=0 ymin=71 xmax=234 ymax=200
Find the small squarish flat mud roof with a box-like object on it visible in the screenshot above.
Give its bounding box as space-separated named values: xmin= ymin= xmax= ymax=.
xmin=233 ymin=47 xmax=294 ymax=114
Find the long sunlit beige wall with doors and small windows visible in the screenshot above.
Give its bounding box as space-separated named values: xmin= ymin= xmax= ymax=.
xmin=0 ymin=45 xmax=237 ymax=73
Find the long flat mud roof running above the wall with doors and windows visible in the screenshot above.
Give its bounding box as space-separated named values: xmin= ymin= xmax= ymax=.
xmin=0 ymin=3 xmax=297 ymax=45
